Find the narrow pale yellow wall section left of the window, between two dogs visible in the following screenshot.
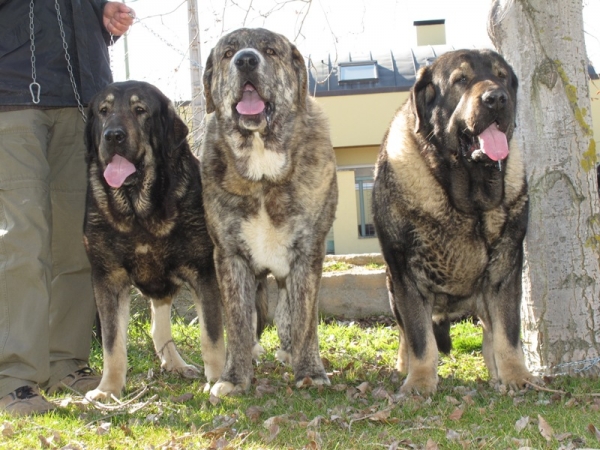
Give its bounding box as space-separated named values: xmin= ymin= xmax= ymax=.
xmin=333 ymin=170 xmax=381 ymax=255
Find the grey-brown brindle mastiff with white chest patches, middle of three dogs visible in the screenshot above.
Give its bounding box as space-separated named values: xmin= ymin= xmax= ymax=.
xmin=201 ymin=29 xmax=337 ymax=396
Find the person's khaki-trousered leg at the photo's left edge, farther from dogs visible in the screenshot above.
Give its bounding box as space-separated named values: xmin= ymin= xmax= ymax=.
xmin=0 ymin=110 xmax=52 ymax=398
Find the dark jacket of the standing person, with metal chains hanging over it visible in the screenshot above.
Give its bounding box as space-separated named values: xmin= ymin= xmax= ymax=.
xmin=0 ymin=0 xmax=112 ymax=107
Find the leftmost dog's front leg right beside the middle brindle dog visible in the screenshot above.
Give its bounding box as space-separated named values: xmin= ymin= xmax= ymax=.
xmin=192 ymin=270 xmax=225 ymax=382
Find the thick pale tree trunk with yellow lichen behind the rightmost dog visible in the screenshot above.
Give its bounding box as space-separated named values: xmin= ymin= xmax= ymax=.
xmin=488 ymin=0 xmax=600 ymax=375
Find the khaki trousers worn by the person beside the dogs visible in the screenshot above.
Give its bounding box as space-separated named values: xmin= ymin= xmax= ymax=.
xmin=0 ymin=108 xmax=95 ymax=398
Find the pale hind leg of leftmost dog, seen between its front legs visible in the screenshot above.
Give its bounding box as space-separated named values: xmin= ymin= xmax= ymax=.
xmin=150 ymin=299 xmax=200 ymax=378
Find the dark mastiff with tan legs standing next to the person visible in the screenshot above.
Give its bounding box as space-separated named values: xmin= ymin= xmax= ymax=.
xmin=84 ymin=81 xmax=225 ymax=399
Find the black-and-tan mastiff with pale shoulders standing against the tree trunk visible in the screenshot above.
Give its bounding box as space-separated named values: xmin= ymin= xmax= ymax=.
xmin=373 ymin=50 xmax=532 ymax=394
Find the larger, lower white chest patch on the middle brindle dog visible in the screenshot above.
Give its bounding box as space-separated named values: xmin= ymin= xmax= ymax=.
xmin=241 ymin=200 xmax=291 ymax=278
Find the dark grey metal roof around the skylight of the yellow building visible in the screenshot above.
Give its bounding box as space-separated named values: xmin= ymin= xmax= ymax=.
xmin=308 ymin=45 xmax=454 ymax=97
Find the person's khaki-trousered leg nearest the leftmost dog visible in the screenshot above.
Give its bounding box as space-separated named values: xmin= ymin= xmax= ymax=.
xmin=47 ymin=108 xmax=100 ymax=391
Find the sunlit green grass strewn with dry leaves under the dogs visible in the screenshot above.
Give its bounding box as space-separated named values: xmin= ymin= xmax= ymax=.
xmin=0 ymin=306 xmax=600 ymax=450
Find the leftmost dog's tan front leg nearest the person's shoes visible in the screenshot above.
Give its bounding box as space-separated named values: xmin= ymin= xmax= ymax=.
xmin=86 ymin=282 xmax=130 ymax=400
